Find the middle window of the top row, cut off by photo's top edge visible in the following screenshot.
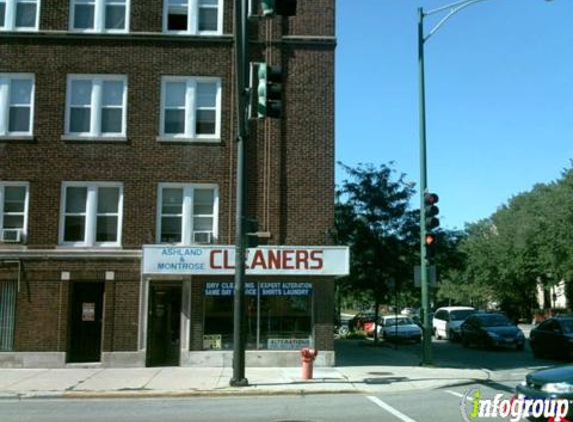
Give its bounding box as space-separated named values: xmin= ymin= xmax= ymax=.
xmin=70 ymin=0 xmax=129 ymax=32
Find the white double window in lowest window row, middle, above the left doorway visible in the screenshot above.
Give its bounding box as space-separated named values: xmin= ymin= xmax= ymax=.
xmin=60 ymin=182 xmax=123 ymax=246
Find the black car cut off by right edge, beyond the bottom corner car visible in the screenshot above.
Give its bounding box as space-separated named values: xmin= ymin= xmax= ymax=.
xmin=529 ymin=316 xmax=573 ymax=360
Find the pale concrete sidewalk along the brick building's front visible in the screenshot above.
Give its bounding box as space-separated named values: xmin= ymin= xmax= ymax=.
xmin=0 ymin=342 xmax=490 ymax=399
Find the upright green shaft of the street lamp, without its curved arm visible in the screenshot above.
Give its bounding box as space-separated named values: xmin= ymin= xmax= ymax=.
xmin=418 ymin=7 xmax=434 ymax=365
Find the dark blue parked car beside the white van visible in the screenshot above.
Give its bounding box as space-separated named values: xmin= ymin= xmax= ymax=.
xmin=461 ymin=312 xmax=525 ymax=350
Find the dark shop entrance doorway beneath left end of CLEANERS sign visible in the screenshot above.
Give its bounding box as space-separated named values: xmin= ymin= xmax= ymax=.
xmin=147 ymin=283 xmax=181 ymax=366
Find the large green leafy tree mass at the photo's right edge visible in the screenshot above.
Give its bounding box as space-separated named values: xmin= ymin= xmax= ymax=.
xmin=460 ymin=169 xmax=573 ymax=316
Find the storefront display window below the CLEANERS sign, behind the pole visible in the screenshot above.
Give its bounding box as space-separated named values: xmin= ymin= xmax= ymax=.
xmin=203 ymin=282 xmax=312 ymax=350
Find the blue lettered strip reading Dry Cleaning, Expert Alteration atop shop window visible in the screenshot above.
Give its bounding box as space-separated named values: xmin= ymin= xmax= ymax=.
xmin=205 ymin=282 xmax=312 ymax=296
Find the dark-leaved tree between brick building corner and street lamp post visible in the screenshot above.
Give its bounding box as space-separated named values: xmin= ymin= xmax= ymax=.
xmin=335 ymin=163 xmax=419 ymax=339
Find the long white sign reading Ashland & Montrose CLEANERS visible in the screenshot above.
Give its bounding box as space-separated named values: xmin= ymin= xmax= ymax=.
xmin=143 ymin=245 xmax=350 ymax=276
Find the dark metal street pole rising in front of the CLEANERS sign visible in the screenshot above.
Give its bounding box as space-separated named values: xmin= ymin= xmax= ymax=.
xmin=229 ymin=0 xmax=249 ymax=387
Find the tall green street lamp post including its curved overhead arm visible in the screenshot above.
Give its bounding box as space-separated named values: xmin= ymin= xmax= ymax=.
xmin=418 ymin=0 xmax=553 ymax=365
